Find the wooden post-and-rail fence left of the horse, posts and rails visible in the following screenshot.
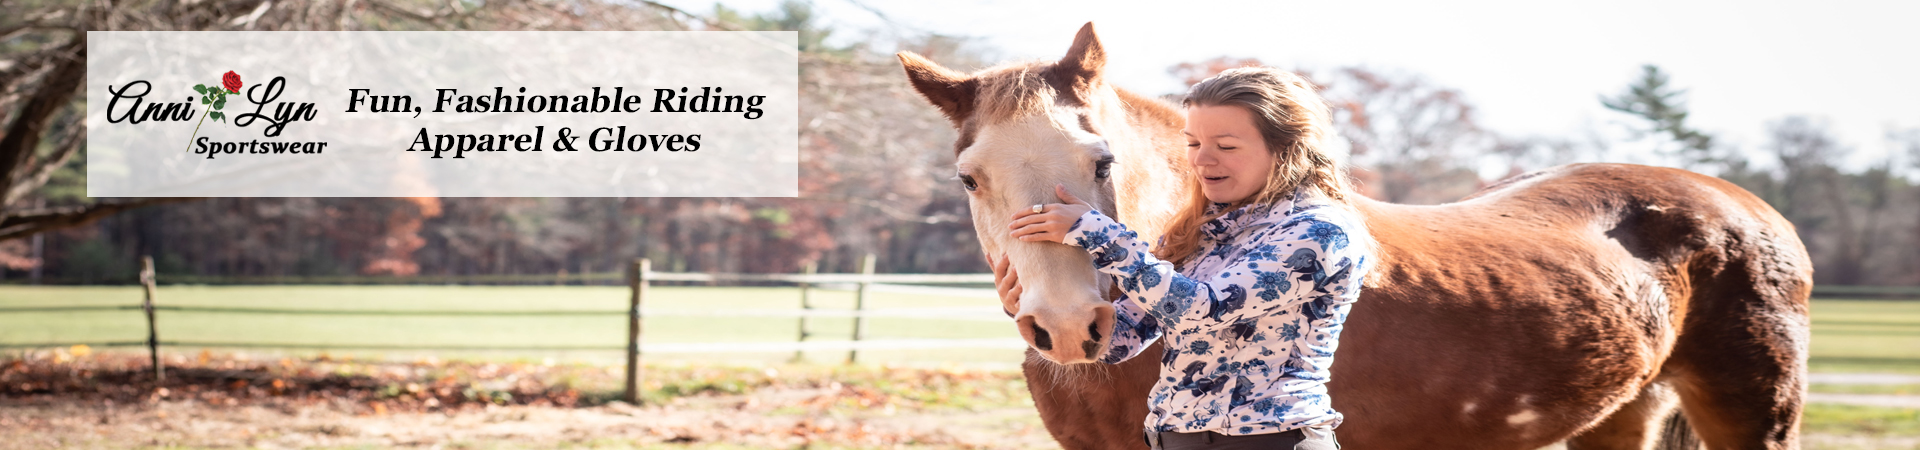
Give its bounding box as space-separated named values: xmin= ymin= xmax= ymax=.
xmin=0 ymin=256 xmax=1025 ymax=402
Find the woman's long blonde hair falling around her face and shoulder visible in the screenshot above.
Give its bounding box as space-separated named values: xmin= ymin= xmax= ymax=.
xmin=1158 ymin=67 xmax=1352 ymax=263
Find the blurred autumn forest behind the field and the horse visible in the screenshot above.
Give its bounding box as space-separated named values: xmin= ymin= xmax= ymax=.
xmin=0 ymin=0 xmax=1920 ymax=285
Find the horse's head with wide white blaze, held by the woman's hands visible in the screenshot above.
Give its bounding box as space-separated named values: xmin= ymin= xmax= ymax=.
xmin=899 ymin=23 xmax=1123 ymax=363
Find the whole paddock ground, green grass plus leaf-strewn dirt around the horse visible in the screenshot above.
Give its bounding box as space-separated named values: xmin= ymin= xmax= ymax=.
xmin=0 ymin=277 xmax=1920 ymax=448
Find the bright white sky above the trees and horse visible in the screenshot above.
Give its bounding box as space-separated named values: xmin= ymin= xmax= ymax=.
xmin=662 ymin=0 xmax=1920 ymax=167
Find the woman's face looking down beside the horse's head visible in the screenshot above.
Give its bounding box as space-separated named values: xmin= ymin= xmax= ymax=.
xmin=1181 ymin=106 xmax=1273 ymax=204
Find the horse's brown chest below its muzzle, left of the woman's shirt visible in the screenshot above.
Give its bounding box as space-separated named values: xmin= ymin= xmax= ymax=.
xmin=1021 ymin=342 xmax=1162 ymax=450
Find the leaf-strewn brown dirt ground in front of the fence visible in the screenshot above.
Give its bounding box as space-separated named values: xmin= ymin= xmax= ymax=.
xmin=0 ymin=354 xmax=1054 ymax=448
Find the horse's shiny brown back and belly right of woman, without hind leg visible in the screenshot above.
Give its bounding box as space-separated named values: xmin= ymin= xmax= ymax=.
xmin=1331 ymin=163 xmax=1809 ymax=448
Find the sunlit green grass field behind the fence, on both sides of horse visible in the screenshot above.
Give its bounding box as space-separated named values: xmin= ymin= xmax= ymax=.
xmin=0 ymin=287 xmax=1920 ymax=373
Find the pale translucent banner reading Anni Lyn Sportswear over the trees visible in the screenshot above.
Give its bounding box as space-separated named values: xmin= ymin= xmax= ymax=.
xmin=86 ymin=31 xmax=799 ymax=196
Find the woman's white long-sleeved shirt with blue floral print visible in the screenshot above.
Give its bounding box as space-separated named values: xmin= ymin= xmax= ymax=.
xmin=1066 ymin=190 xmax=1373 ymax=435
